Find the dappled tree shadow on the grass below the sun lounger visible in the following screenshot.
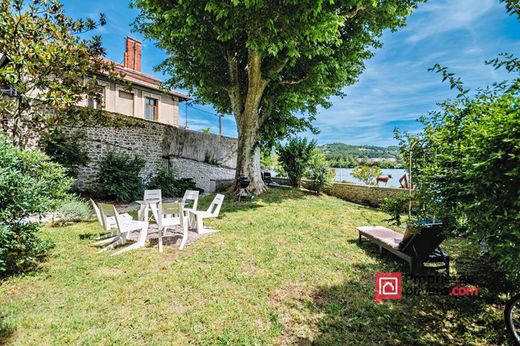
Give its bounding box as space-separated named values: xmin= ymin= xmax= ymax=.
xmin=296 ymin=246 xmax=506 ymax=345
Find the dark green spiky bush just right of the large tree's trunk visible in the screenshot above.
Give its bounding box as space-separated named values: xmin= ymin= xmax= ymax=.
xmin=278 ymin=137 xmax=316 ymax=187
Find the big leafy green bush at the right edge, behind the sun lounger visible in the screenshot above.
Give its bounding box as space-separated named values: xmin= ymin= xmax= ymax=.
xmin=402 ymin=55 xmax=520 ymax=284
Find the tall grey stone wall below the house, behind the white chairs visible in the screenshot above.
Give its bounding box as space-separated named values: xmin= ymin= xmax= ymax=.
xmin=72 ymin=120 xmax=237 ymax=191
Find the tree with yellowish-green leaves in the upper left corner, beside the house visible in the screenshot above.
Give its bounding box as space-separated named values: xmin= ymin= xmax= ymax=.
xmin=0 ymin=0 xmax=116 ymax=148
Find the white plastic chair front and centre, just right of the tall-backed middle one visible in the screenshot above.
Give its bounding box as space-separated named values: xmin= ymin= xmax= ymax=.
xmin=157 ymin=202 xmax=188 ymax=252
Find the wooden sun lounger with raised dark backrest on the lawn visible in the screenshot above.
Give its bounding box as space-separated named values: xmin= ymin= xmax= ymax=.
xmin=356 ymin=224 xmax=450 ymax=275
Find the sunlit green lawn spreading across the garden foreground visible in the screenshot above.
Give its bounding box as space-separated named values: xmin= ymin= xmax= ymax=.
xmin=0 ymin=189 xmax=506 ymax=345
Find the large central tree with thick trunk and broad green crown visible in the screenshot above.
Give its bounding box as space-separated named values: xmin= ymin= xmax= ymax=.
xmin=134 ymin=0 xmax=422 ymax=193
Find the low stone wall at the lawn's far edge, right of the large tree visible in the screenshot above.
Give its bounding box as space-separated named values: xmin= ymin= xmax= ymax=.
xmin=273 ymin=178 xmax=408 ymax=207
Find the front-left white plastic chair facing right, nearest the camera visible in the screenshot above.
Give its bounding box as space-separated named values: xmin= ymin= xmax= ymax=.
xmin=98 ymin=203 xmax=148 ymax=256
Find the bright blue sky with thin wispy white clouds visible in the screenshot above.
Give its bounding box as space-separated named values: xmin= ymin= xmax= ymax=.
xmin=63 ymin=0 xmax=520 ymax=145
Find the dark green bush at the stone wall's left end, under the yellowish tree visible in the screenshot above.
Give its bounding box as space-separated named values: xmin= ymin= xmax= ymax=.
xmin=39 ymin=127 xmax=89 ymax=176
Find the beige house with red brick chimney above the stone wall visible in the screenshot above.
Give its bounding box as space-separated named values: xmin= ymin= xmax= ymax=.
xmin=80 ymin=36 xmax=190 ymax=126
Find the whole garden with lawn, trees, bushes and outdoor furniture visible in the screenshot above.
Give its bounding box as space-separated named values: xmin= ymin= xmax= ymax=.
xmin=0 ymin=0 xmax=520 ymax=345
